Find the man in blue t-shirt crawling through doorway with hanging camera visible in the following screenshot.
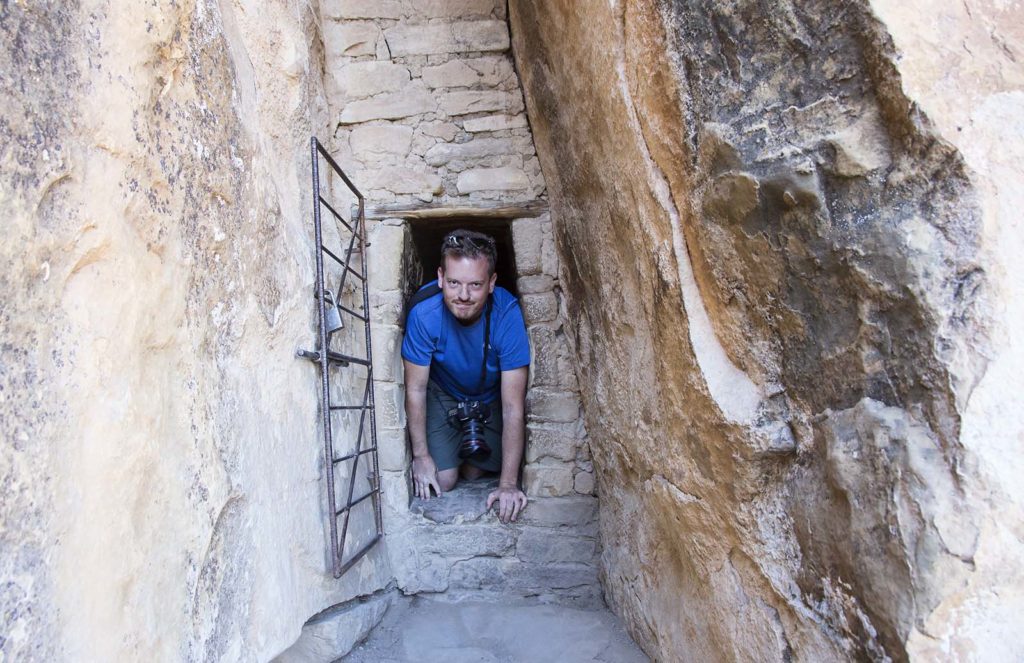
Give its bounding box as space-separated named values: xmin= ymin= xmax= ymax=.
xmin=401 ymin=231 xmax=529 ymax=523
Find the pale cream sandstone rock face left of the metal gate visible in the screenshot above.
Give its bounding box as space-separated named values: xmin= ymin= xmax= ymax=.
xmin=0 ymin=0 xmax=391 ymax=661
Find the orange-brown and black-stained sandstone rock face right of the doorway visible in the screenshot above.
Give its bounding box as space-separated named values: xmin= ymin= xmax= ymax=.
xmin=510 ymin=0 xmax=1024 ymax=661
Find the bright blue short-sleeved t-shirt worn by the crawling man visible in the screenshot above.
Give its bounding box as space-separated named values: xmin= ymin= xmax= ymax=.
xmin=401 ymin=284 xmax=529 ymax=403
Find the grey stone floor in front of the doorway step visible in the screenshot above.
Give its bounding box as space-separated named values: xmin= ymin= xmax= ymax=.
xmin=341 ymin=597 xmax=648 ymax=663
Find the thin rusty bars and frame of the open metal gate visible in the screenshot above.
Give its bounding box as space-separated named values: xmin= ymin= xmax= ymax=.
xmin=298 ymin=136 xmax=384 ymax=578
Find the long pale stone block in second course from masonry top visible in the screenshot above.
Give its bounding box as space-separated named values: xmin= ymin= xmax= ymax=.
xmin=384 ymin=20 xmax=509 ymax=57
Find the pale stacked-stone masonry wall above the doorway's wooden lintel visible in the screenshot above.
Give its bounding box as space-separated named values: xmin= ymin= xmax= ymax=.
xmin=322 ymin=0 xmax=544 ymax=203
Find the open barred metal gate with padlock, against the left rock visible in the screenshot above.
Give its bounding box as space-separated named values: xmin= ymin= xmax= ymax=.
xmin=298 ymin=137 xmax=384 ymax=578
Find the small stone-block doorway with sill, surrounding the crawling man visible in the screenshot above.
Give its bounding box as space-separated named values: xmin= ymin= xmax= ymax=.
xmin=360 ymin=211 xmax=603 ymax=607
